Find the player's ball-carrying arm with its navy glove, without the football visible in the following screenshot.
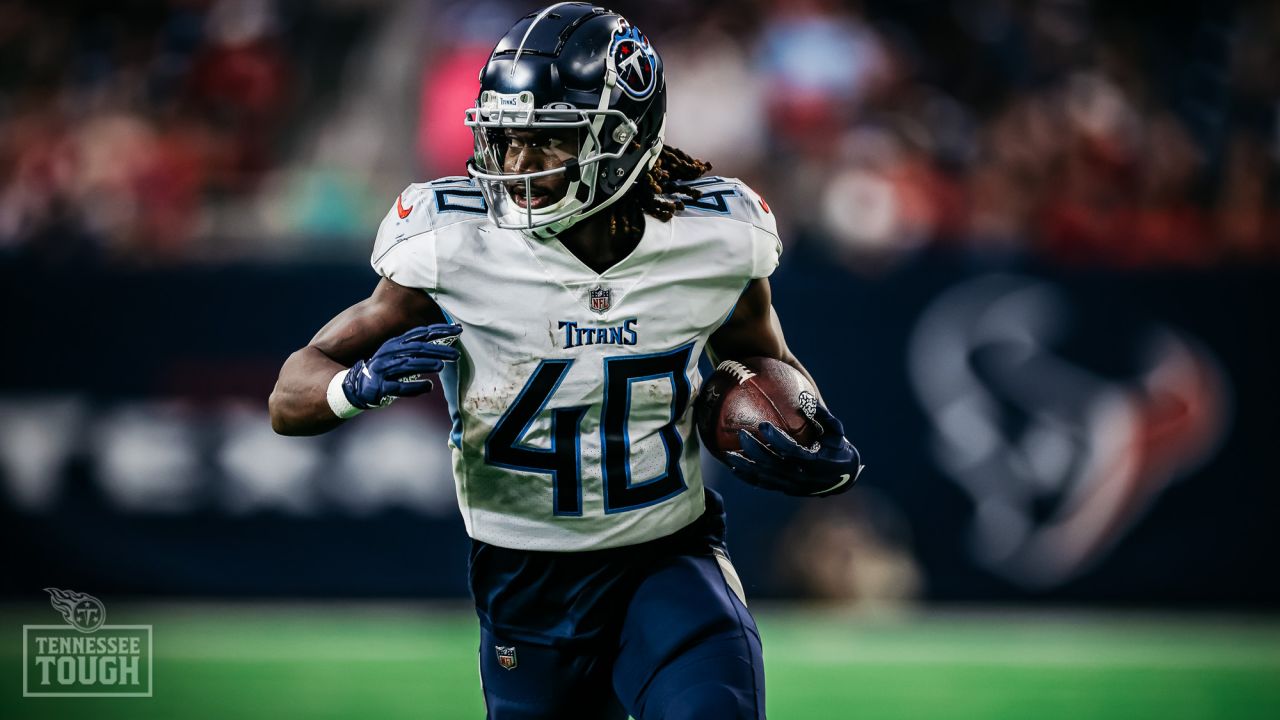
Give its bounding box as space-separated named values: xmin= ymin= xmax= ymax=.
xmin=708 ymin=278 xmax=863 ymax=497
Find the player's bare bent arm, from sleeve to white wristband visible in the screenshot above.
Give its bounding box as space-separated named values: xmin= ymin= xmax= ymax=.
xmin=268 ymin=278 xmax=455 ymax=436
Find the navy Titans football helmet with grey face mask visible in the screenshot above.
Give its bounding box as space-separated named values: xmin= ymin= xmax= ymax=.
xmin=466 ymin=3 xmax=667 ymax=238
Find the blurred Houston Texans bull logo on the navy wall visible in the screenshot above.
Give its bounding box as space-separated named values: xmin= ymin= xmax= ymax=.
xmin=909 ymin=275 xmax=1230 ymax=588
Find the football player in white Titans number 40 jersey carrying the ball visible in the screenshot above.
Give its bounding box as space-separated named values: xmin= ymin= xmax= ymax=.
xmin=270 ymin=3 xmax=861 ymax=720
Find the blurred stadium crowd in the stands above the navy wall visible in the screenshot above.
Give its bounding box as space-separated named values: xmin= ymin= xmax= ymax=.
xmin=0 ymin=0 xmax=1280 ymax=266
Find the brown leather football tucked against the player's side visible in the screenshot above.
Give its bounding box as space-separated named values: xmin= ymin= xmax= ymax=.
xmin=694 ymin=357 xmax=822 ymax=457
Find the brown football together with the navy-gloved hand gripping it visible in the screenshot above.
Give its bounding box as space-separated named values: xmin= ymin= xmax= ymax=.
xmin=695 ymin=357 xmax=863 ymax=497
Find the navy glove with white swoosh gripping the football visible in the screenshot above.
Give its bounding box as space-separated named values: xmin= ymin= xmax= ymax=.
xmin=724 ymin=405 xmax=863 ymax=497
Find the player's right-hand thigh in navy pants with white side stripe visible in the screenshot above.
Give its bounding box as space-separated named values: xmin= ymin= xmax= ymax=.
xmin=613 ymin=545 xmax=764 ymax=720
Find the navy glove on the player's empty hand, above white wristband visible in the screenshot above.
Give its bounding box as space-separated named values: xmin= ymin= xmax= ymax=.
xmin=342 ymin=324 xmax=462 ymax=410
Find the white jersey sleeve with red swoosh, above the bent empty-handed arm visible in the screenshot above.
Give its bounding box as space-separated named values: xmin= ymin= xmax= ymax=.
xmin=369 ymin=184 xmax=439 ymax=292
